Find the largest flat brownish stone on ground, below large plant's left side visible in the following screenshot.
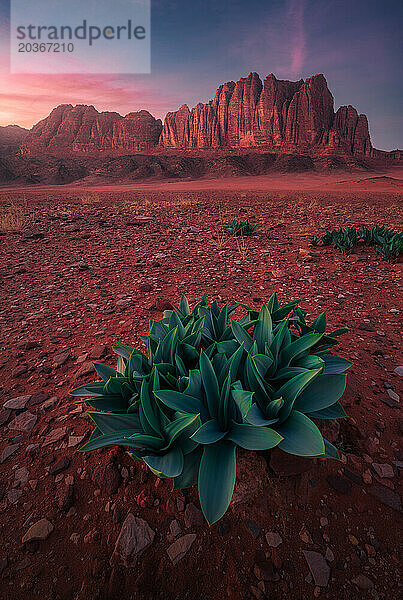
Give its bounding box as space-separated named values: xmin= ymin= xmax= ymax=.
xmin=110 ymin=513 xmax=155 ymax=567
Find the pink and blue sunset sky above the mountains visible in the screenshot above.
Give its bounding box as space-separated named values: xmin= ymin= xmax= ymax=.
xmin=0 ymin=0 xmax=402 ymax=150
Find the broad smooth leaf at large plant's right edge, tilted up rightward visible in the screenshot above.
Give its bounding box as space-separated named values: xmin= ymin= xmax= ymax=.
xmin=293 ymin=374 xmax=347 ymax=413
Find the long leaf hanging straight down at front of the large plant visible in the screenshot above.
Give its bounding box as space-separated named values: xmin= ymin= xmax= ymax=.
xmin=199 ymin=440 xmax=236 ymax=525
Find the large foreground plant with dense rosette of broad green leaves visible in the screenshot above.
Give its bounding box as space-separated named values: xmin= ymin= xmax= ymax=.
xmin=71 ymin=294 xmax=351 ymax=523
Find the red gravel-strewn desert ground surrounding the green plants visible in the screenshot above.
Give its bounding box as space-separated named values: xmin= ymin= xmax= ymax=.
xmin=0 ymin=187 xmax=403 ymax=600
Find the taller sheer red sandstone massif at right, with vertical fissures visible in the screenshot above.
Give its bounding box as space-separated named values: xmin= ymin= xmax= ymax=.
xmin=160 ymin=73 xmax=372 ymax=156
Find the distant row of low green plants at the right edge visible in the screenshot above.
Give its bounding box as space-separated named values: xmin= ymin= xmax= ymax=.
xmin=320 ymin=225 xmax=403 ymax=262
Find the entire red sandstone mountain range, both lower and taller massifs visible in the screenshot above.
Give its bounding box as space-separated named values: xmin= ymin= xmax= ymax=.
xmin=15 ymin=73 xmax=394 ymax=157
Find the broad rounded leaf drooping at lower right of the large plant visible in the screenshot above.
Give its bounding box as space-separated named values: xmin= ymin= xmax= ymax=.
xmin=274 ymin=410 xmax=325 ymax=456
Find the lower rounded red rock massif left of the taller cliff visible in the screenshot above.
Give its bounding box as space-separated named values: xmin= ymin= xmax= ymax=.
xmin=20 ymin=104 xmax=162 ymax=154
